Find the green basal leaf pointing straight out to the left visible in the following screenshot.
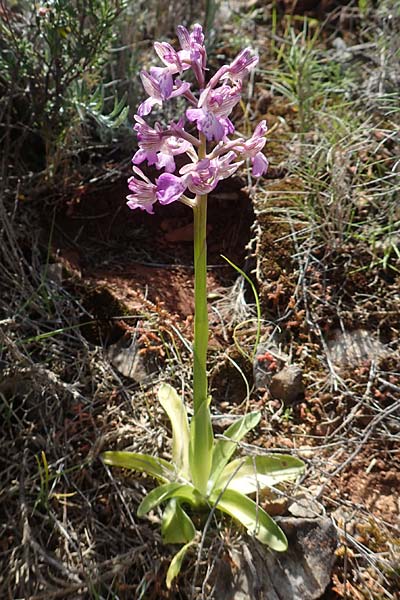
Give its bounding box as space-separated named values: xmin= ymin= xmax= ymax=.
xmin=101 ymin=452 xmax=176 ymax=483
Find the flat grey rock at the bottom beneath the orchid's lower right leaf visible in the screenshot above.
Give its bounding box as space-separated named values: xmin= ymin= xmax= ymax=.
xmin=213 ymin=517 xmax=338 ymax=600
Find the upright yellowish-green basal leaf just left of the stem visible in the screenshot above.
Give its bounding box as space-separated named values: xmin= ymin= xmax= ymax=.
xmin=158 ymin=383 xmax=190 ymax=478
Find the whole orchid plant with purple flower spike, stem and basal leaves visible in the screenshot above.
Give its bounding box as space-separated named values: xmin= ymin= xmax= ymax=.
xmin=103 ymin=25 xmax=304 ymax=587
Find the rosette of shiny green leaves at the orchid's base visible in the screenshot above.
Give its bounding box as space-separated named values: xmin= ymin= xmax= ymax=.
xmin=102 ymin=384 xmax=304 ymax=587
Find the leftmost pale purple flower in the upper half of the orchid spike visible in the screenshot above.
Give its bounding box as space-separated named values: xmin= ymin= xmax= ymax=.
xmin=138 ymin=67 xmax=190 ymax=117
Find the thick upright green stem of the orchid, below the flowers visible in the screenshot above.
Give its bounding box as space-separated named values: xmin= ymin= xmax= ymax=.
xmin=189 ymin=139 xmax=213 ymax=494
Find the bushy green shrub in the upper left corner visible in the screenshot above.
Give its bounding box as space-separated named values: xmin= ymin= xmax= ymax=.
xmin=0 ymin=0 xmax=126 ymax=175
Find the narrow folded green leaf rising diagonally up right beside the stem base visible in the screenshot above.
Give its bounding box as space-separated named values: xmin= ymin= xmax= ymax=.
xmin=210 ymin=411 xmax=261 ymax=489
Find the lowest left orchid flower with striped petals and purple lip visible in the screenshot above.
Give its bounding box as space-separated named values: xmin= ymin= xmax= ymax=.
xmin=126 ymin=167 xmax=186 ymax=215
